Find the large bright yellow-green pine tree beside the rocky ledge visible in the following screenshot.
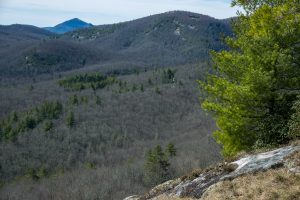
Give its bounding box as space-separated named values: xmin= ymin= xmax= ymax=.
xmin=200 ymin=0 xmax=300 ymax=155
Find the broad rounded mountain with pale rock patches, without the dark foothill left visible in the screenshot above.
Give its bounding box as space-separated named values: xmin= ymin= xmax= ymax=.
xmin=63 ymin=11 xmax=231 ymax=65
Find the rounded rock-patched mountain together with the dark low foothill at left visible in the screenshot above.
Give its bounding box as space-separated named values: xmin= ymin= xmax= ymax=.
xmin=0 ymin=11 xmax=231 ymax=76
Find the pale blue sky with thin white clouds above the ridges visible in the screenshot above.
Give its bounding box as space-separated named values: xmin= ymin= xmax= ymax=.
xmin=0 ymin=0 xmax=236 ymax=27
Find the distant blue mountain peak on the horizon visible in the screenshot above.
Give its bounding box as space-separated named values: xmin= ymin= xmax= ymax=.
xmin=44 ymin=18 xmax=93 ymax=34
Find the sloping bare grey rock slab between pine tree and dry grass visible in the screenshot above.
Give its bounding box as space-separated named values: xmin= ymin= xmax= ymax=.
xmin=125 ymin=145 xmax=300 ymax=200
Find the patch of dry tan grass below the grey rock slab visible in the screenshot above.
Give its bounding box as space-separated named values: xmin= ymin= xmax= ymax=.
xmin=203 ymin=168 xmax=300 ymax=200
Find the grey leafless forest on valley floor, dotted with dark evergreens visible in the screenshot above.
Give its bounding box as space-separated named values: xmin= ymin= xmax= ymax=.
xmin=0 ymin=63 xmax=221 ymax=200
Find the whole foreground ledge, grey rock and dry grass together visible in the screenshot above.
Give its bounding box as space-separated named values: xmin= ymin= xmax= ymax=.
xmin=125 ymin=145 xmax=300 ymax=200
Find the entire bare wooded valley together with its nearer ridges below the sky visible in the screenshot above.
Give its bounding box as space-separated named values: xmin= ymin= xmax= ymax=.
xmin=0 ymin=11 xmax=231 ymax=200
